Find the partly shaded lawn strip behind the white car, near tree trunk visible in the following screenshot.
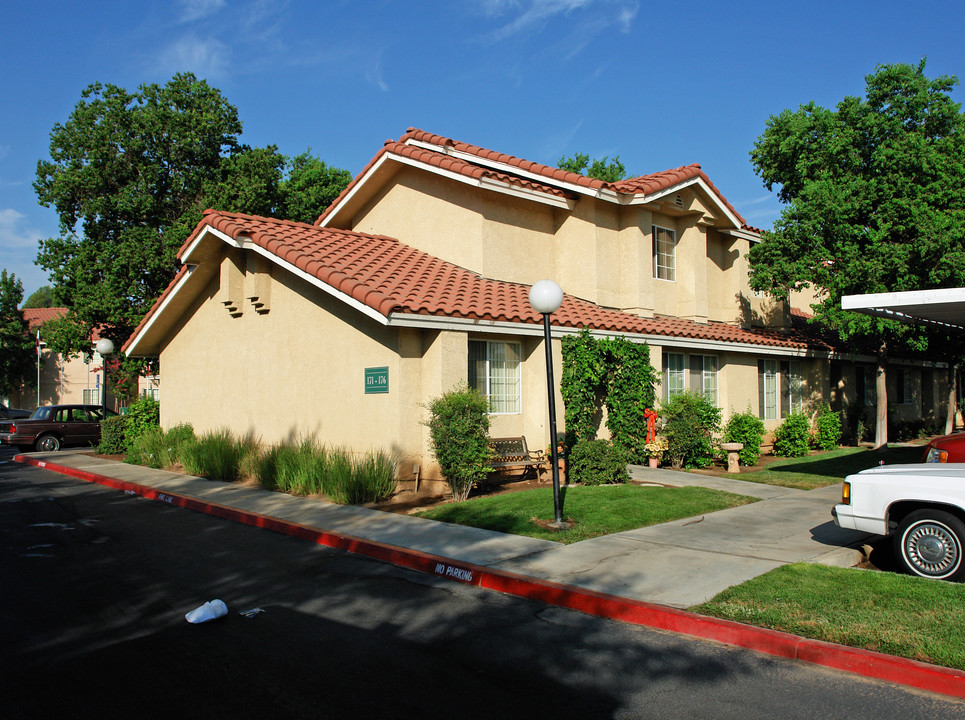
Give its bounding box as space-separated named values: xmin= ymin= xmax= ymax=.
xmin=726 ymin=447 xmax=922 ymax=490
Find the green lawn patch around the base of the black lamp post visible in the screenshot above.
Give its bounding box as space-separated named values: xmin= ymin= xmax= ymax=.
xmin=419 ymin=485 xmax=756 ymax=543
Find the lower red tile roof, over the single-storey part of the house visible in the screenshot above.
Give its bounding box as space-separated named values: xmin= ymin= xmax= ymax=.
xmin=137 ymin=210 xmax=829 ymax=349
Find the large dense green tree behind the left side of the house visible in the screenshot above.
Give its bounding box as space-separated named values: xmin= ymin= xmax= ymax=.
xmin=34 ymin=74 xmax=350 ymax=370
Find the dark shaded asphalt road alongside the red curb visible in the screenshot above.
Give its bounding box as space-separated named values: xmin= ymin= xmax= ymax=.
xmin=0 ymin=462 xmax=965 ymax=720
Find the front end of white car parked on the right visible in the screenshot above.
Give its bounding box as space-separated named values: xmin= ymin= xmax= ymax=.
xmin=831 ymin=463 xmax=965 ymax=581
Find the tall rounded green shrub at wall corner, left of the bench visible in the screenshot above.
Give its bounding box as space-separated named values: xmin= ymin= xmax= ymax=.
xmin=425 ymin=385 xmax=492 ymax=500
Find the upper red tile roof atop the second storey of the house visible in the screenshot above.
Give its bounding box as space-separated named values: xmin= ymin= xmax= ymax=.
xmin=315 ymin=128 xmax=756 ymax=231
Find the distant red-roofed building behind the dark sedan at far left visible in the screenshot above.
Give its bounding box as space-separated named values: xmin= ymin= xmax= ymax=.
xmin=10 ymin=308 xmax=158 ymax=410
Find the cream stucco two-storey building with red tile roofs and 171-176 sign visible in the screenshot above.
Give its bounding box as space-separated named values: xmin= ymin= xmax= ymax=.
xmin=124 ymin=129 xmax=944 ymax=475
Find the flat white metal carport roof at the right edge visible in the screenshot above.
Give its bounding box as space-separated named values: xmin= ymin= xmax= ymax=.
xmin=841 ymin=288 xmax=965 ymax=332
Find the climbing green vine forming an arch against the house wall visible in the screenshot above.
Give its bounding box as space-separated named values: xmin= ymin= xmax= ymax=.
xmin=560 ymin=328 xmax=657 ymax=461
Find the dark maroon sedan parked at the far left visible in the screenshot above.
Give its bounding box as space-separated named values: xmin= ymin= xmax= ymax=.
xmin=0 ymin=405 xmax=116 ymax=451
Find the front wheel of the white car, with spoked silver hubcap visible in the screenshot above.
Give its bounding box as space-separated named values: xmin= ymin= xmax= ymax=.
xmin=895 ymin=510 xmax=965 ymax=582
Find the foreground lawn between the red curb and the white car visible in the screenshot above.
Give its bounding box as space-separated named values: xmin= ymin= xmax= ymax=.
xmin=690 ymin=563 xmax=965 ymax=670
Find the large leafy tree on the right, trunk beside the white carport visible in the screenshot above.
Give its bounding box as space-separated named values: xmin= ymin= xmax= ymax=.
xmin=749 ymin=60 xmax=965 ymax=446
